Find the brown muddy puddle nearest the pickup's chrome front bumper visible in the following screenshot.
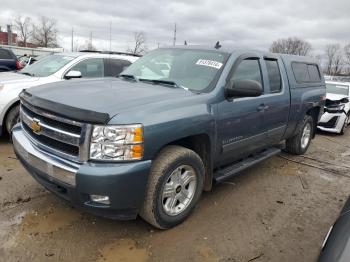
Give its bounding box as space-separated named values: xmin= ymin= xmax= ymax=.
xmin=20 ymin=208 xmax=81 ymax=235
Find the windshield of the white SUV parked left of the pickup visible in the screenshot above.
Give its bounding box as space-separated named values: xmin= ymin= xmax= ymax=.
xmin=19 ymin=55 xmax=74 ymax=77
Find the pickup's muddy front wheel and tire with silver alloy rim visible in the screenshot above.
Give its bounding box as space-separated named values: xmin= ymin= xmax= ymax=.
xmin=140 ymin=146 xmax=205 ymax=229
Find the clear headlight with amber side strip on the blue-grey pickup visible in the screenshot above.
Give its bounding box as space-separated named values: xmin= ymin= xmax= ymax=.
xmin=90 ymin=124 xmax=143 ymax=161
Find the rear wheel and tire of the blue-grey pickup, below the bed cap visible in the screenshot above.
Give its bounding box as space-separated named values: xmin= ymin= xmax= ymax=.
xmin=286 ymin=115 xmax=315 ymax=155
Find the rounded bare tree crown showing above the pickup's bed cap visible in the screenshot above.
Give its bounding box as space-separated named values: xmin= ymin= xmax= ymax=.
xmin=270 ymin=37 xmax=312 ymax=56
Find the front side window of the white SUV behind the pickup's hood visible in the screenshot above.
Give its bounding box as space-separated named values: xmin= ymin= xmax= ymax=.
xmin=70 ymin=58 xmax=104 ymax=78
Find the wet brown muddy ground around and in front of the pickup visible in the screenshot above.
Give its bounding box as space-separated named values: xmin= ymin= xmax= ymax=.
xmin=0 ymin=132 xmax=350 ymax=262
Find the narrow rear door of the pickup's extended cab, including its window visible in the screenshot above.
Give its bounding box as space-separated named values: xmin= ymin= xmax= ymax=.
xmin=262 ymin=56 xmax=290 ymax=145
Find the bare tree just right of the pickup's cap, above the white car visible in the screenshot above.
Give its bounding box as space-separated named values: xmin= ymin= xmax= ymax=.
xmin=326 ymin=44 xmax=343 ymax=75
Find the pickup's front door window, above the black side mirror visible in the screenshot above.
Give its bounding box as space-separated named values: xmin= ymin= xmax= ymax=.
xmin=231 ymin=59 xmax=263 ymax=86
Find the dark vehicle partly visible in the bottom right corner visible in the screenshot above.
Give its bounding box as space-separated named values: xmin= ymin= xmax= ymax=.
xmin=318 ymin=195 xmax=350 ymax=262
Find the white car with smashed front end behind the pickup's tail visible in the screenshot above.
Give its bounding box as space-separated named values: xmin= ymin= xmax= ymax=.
xmin=317 ymin=81 xmax=350 ymax=134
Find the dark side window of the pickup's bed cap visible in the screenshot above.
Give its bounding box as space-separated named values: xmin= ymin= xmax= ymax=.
xmin=292 ymin=62 xmax=321 ymax=83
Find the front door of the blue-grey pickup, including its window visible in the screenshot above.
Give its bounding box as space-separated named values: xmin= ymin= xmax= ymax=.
xmin=217 ymin=56 xmax=267 ymax=165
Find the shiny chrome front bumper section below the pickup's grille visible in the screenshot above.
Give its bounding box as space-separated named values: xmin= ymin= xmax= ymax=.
xmin=12 ymin=124 xmax=79 ymax=187
